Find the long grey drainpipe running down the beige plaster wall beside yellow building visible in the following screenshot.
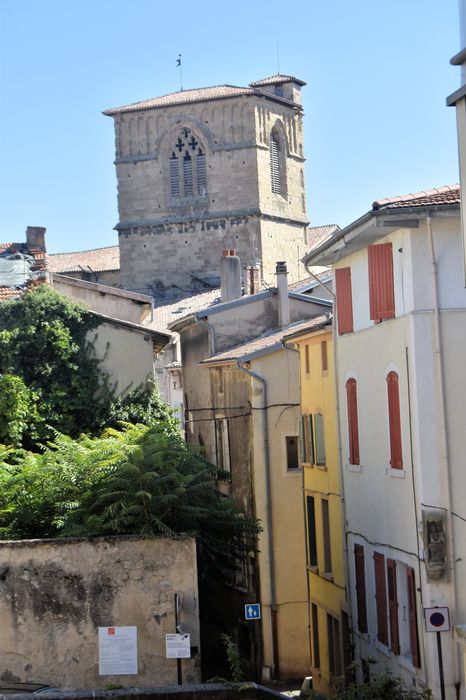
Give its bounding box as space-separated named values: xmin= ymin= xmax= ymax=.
xmin=236 ymin=362 xmax=280 ymax=680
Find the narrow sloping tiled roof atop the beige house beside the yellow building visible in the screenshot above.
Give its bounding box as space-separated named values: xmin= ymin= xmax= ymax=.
xmin=200 ymin=314 xmax=330 ymax=365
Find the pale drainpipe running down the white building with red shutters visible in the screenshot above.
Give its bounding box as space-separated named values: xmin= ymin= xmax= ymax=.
xmin=426 ymin=214 xmax=460 ymax=686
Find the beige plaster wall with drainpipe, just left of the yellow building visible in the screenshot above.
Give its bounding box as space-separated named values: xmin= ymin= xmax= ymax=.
xmin=251 ymin=350 xmax=309 ymax=678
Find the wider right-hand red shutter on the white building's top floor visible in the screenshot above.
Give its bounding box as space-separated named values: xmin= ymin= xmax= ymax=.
xmin=367 ymin=243 xmax=395 ymax=321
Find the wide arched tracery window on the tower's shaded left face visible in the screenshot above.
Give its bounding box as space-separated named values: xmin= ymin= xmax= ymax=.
xmin=169 ymin=127 xmax=207 ymax=199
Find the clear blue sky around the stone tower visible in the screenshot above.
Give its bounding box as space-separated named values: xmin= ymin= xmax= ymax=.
xmin=0 ymin=0 xmax=460 ymax=252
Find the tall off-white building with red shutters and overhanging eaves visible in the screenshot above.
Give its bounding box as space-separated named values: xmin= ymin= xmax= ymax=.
xmin=308 ymin=185 xmax=466 ymax=700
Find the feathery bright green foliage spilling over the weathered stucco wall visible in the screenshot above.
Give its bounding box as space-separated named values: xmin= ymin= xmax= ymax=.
xmin=0 ymin=424 xmax=258 ymax=575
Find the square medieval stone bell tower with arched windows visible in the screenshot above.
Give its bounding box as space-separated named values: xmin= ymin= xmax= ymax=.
xmin=104 ymin=75 xmax=308 ymax=297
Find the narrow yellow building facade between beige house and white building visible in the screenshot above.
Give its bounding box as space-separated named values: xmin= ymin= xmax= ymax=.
xmin=292 ymin=326 xmax=351 ymax=694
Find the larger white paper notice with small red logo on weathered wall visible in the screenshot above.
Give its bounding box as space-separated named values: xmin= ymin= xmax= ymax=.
xmin=99 ymin=627 xmax=138 ymax=676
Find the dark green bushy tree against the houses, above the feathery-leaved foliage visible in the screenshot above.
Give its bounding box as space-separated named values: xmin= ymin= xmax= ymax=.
xmin=0 ymin=285 xmax=111 ymax=448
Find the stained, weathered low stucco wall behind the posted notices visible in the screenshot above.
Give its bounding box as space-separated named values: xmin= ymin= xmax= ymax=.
xmin=0 ymin=537 xmax=200 ymax=689
